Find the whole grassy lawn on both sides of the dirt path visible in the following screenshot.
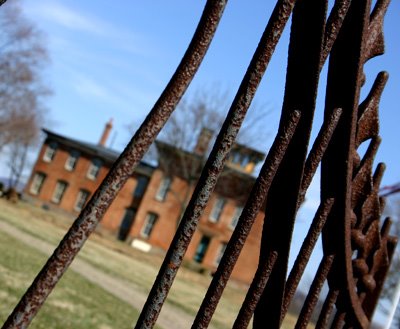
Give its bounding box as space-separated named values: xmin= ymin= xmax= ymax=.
xmin=0 ymin=200 xmax=302 ymax=329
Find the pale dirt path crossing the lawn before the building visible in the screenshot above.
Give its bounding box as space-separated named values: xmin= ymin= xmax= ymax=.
xmin=0 ymin=221 xmax=193 ymax=329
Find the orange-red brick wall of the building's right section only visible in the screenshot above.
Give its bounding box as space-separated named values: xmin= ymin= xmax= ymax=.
xmin=130 ymin=169 xmax=264 ymax=283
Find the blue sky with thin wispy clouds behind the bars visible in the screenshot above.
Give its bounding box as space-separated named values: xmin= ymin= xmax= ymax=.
xmin=9 ymin=0 xmax=400 ymax=322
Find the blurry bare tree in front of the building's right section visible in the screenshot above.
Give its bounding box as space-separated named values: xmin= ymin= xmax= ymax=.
xmin=139 ymin=88 xmax=269 ymax=222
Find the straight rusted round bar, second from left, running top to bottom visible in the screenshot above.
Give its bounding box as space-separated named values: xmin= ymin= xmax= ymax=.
xmin=135 ymin=0 xmax=295 ymax=328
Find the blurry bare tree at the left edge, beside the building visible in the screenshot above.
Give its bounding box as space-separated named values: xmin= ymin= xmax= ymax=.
xmin=0 ymin=1 xmax=50 ymax=190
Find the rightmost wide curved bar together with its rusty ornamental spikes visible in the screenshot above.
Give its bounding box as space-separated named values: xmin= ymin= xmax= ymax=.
xmin=321 ymin=1 xmax=396 ymax=328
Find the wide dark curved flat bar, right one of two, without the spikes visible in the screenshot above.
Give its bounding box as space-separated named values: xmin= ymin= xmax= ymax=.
xmin=321 ymin=1 xmax=376 ymax=328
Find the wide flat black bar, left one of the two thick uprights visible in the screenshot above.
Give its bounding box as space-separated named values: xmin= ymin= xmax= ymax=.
xmin=253 ymin=1 xmax=327 ymax=329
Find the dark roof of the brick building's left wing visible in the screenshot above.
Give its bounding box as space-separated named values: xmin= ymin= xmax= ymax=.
xmin=42 ymin=128 xmax=155 ymax=175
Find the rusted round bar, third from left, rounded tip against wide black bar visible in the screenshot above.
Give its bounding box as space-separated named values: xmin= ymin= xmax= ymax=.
xmin=192 ymin=111 xmax=300 ymax=328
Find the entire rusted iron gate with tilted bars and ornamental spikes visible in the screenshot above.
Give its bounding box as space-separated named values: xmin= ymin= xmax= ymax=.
xmin=2 ymin=0 xmax=396 ymax=328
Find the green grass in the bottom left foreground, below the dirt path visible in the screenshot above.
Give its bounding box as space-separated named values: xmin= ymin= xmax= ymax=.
xmin=0 ymin=229 xmax=138 ymax=329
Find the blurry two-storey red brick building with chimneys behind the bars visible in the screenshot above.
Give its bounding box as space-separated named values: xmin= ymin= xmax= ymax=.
xmin=24 ymin=121 xmax=264 ymax=283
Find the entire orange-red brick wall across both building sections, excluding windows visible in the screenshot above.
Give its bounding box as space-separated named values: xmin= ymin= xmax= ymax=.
xmin=25 ymin=137 xmax=264 ymax=283
